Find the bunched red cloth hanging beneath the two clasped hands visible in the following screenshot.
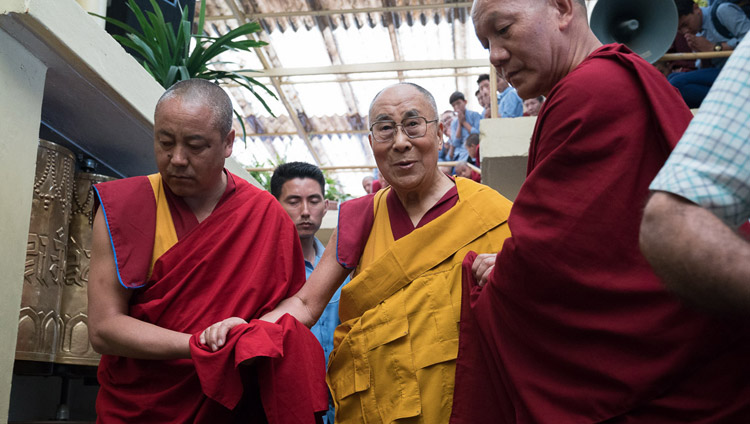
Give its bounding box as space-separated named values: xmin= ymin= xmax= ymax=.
xmin=190 ymin=314 xmax=328 ymax=424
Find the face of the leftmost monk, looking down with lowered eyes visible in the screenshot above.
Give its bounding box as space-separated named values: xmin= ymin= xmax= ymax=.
xmin=154 ymin=97 xmax=234 ymax=199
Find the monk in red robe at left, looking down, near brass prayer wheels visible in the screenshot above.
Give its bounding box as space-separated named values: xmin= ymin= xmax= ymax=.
xmin=88 ymin=79 xmax=327 ymax=423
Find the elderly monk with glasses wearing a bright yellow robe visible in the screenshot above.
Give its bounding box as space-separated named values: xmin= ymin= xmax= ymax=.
xmin=206 ymin=83 xmax=511 ymax=423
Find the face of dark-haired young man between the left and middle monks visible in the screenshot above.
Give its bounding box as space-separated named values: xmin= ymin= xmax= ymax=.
xmin=279 ymin=178 xmax=328 ymax=239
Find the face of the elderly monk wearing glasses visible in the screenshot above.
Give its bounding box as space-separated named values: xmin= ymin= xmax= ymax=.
xmin=369 ymin=85 xmax=443 ymax=192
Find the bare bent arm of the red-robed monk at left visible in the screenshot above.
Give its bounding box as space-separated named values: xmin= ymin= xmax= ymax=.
xmin=88 ymin=209 xmax=190 ymax=359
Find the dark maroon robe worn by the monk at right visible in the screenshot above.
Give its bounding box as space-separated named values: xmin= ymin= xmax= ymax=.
xmin=453 ymin=45 xmax=750 ymax=424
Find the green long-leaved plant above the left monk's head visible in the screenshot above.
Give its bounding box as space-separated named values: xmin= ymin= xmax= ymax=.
xmin=92 ymin=0 xmax=276 ymax=138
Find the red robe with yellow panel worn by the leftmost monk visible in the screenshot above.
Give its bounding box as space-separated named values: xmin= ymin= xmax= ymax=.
xmin=96 ymin=172 xmax=327 ymax=423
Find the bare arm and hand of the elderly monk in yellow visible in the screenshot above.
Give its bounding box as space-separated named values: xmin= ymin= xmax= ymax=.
xmin=200 ymin=230 xmax=351 ymax=351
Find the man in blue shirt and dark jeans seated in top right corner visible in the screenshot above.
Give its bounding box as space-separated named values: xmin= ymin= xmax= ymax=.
xmin=668 ymin=0 xmax=750 ymax=108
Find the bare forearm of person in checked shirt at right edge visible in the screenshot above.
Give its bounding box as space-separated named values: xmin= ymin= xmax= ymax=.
xmin=640 ymin=192 xmax=750 ymax=315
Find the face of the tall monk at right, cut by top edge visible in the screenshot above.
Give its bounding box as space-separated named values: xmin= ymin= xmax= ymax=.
xmin=472 ymin=0 xmax=564 ymax=98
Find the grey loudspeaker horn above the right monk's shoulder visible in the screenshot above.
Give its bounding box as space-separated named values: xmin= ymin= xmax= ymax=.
xmin=590 ymin=0 xmax=677 ymax=63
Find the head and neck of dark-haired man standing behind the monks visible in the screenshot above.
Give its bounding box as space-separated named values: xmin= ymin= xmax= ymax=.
xmin=271 ymin=162 xmax=328 ymax=263
